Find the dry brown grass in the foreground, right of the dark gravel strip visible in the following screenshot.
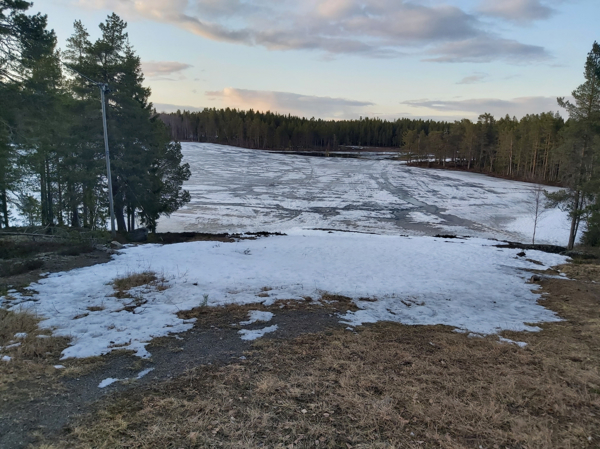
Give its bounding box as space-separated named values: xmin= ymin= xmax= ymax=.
xmin=37 ymin=265 xmax=600 ymax=449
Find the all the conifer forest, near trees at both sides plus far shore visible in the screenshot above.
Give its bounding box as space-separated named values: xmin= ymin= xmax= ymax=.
xmin=0 ymin=0 xmax=600 ymax=247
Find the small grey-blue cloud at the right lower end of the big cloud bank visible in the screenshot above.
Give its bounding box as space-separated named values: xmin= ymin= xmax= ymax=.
xmin=425 ymin=37 xmax=551 ymax=64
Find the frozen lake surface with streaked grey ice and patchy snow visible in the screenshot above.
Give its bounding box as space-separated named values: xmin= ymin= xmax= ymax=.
xmin=158 ymin=143 xmax=569 ymax=245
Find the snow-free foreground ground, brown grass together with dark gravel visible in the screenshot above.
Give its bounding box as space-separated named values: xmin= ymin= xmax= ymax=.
xmin=0 ymin=234 xmax=600 ymax=449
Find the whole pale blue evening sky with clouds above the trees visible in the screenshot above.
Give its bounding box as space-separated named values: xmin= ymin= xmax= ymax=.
xmin=32 ymin=0 xmax=600 ymax=120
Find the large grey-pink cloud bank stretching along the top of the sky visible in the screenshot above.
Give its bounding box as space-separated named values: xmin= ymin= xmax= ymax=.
xmin=74 ymin=0 xmax=543 ymax=62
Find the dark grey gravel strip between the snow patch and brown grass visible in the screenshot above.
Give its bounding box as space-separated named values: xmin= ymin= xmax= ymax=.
xmin=0 ymin=297 xmax=350 ymax=449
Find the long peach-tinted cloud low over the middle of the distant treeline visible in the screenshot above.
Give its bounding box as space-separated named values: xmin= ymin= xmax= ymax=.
xmin=206 ymin=87 xmax=374 ymax=119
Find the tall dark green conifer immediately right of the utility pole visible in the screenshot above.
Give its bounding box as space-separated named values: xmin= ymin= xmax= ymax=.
xmin=67 ymin=14 xmax=190 ymax=232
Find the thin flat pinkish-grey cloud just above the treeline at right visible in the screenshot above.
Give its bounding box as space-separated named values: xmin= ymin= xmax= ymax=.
xmin=401 ymin=97 xmax=563 ymax=118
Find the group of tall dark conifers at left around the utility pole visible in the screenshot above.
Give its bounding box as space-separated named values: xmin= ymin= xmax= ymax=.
xmin=0 ymin=0 xmax=190 ymax=231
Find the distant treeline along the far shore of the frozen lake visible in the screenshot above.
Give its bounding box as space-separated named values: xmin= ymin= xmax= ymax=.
xmin=161 ymin=108 xmax=568 ymax=182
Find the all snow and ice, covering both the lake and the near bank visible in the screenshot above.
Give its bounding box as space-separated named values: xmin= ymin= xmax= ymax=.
xmin=0 ymin=143 xmax=568 ymax=360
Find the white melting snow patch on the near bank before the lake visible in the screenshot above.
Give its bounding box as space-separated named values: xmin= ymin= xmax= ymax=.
xmin=0 ymin=229 xmax=567 ymax=358
